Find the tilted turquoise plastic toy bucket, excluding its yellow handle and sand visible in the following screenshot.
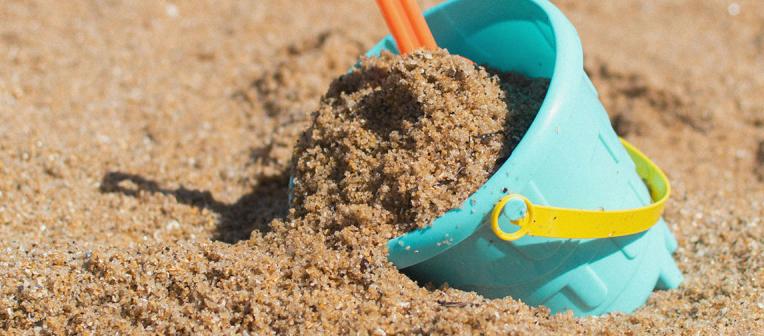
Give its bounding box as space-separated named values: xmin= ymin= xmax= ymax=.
xmin=368 ymin=0 xmax=682 ymax=315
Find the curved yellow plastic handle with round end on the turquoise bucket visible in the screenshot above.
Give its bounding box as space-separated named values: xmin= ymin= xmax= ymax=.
xmin=491 ymin=139 xmax=671 ymax=240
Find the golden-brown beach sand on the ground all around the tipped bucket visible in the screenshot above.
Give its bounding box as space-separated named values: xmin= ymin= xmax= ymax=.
xmin=0 ymin=0 xmax=764 ymax=334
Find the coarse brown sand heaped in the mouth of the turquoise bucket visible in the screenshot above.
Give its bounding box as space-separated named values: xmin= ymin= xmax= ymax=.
xmin=292 ymin=50 xmax=548 ymax=233
